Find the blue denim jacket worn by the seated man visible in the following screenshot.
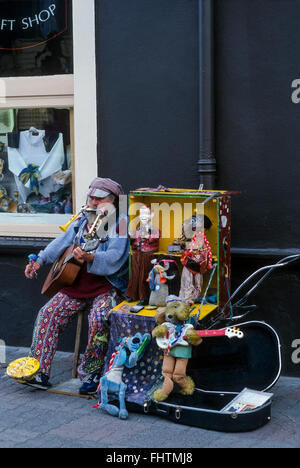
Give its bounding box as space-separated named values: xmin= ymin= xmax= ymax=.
xmin=37 ymin=215 xmax=129 ymax=293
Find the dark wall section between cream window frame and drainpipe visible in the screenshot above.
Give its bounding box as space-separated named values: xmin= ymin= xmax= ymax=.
xmin=96 ymin=0 xmax=199 ymax=190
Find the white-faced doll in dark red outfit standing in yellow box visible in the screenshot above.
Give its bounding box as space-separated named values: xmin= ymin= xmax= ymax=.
xmin=125 ymin=205 xmax=161 ymax=304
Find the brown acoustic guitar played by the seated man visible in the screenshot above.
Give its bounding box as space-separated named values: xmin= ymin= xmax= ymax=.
xmin=42 ymin=239 xmax=100 ymax=297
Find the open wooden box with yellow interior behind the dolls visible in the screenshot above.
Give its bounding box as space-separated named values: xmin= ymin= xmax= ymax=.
xmin=114 ymin=189 xmax=233 ymax=326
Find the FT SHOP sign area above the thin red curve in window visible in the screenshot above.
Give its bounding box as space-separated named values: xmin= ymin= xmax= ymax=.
xmin=0 ymin=0 xmax=68 ymax=50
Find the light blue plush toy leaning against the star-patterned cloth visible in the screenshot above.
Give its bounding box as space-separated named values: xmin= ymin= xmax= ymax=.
xmin=99 ymin=333 xmax=151 ymax=419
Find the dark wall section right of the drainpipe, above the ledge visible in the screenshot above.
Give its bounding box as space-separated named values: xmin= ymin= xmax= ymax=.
xmin=215 ymin=0 xmax=300 ymax=249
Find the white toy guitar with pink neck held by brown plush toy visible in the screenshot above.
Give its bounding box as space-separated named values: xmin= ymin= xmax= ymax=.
xmin=156 ymin=322 xmax=244 ymax=349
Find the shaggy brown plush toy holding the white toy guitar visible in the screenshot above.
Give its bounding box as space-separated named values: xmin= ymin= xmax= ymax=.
xmin=152 ymin=296 xmax=202 ymax=401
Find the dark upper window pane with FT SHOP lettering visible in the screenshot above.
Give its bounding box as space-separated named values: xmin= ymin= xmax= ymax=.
xmin=0 ymin=0 xmax=73 ymax=77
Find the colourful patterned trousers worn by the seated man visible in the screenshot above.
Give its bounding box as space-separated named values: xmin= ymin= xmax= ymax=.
xmin=30 ymin=291 xmax=120 ymax=378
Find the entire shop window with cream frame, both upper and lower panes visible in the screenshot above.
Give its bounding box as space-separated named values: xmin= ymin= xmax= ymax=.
xmin=0 ymin=0 xmax=98 ymax=236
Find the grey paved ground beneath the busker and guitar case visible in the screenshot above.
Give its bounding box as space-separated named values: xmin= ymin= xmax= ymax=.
xmin=0 ymin=348 xmax=300 ymax=450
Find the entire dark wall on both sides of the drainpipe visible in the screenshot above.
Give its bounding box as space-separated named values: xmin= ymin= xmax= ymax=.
xmin=96 ymin=0 xmax=300 ymax=376
